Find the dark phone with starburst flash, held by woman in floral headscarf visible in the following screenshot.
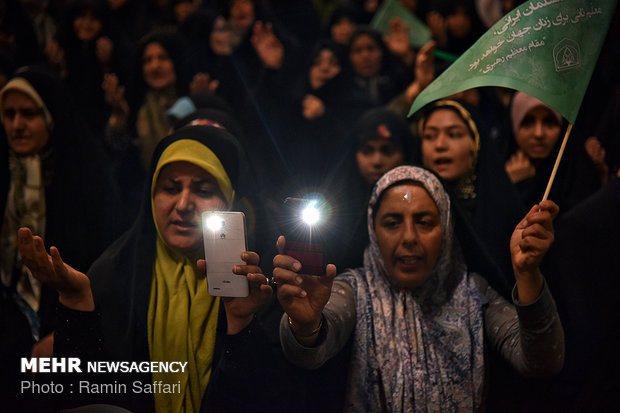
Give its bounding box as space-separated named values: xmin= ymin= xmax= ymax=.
xmin=282 ymin=197 xmax=327 ymax=275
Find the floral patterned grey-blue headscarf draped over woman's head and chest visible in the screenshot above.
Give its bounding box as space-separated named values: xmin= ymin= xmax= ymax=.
xmin=340 ymin=166 xmax=486 ymax=412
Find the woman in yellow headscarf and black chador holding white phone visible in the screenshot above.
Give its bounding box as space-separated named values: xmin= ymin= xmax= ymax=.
xmin=19 ymin=126 xmax=272 ymax=412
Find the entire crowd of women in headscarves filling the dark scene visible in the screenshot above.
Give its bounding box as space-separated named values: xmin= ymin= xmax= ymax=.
xmin=0 ymin=0 xmax=620 ymax=412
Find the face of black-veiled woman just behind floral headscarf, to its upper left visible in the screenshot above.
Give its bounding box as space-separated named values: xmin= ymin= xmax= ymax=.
xmin=356 ymin=139 xmax=405 ymax=185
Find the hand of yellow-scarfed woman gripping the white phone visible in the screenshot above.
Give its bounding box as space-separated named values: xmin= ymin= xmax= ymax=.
xmin=198 ymin=251 xmax=273 ymax=334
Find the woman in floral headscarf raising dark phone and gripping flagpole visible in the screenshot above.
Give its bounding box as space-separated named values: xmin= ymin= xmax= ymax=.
xmin=274 ymin=166 xmax=564 ymax=411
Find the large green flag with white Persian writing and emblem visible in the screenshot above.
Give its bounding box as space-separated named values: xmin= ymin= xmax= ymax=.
xmin=409 ymin=0 xmax=617 ymax=123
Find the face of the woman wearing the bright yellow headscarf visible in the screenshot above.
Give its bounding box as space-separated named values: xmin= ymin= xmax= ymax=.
xmin=153 ymin=162 xmax=226 ymax=255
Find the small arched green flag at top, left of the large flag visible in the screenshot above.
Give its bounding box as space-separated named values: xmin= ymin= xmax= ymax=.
xmin=370 ymin=0 xmax=431 ymax=48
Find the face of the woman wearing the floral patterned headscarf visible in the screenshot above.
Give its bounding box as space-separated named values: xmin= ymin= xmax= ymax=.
xmin=375 ymin=184 xmax=442 ymax=288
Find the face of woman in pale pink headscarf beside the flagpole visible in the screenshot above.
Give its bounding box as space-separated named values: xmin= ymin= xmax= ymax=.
xmin=515 ymin=106 xmax=560 ymax=159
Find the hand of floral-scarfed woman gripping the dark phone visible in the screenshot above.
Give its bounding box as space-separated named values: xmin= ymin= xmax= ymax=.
xmin=273 ymin=236 xmax=336 ymax=337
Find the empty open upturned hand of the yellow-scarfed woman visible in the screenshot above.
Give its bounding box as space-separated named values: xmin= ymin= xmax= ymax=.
xmin=17 ymin=228 xmax=95 ymax=311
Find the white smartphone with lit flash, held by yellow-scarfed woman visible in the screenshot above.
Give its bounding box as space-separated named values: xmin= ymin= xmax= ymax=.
xmin=202 ymin=211 xmax=250 ymax=297
